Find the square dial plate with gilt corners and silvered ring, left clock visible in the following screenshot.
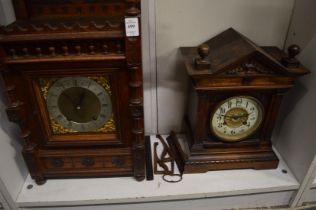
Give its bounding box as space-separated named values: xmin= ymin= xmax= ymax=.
xmin=40 ymin=76 xmax=116 ymax=134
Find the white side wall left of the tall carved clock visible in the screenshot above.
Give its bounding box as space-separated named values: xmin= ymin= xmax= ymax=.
xmin=0 ymin=0 xmax=27 ymax=203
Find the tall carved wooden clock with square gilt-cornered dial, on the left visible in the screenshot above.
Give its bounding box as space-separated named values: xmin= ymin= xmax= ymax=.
xmin=0 ymin=0 xmax=145 ymax=184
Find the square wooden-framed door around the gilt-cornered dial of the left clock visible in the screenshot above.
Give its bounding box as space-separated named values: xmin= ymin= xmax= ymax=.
xmin=30 ymin=69 xmax=129 ymax=146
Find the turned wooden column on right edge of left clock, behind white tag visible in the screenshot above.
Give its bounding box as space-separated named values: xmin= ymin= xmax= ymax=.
xmin=125 ymin=0 xmax=145 ymax=181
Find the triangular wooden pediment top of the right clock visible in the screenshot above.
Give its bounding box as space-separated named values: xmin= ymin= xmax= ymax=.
xmin=181 ymin=28 xmax=308 ymax=77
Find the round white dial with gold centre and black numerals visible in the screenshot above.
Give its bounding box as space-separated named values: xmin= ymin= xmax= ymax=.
xmin=211 ymin=96 xmax=263 ymax=141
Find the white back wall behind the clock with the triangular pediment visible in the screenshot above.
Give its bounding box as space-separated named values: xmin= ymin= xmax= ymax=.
xmin=156 ymin=0 xmax=294 ymax=133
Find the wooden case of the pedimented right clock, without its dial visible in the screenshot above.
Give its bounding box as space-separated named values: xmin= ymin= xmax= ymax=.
xmin=177 ymin=28 xmax=309 ymax=173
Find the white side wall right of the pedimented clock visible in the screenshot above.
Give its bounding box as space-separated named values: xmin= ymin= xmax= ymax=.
xmin=274 ymin=0 xmax=316 ymax=182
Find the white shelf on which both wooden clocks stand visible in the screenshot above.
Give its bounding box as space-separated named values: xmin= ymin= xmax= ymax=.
xmin=17 ymin=136 xmax=299 ymax=207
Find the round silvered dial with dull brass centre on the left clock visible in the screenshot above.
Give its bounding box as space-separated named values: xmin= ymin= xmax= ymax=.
xmin=46 ymin=77 xmax=112 ymax=132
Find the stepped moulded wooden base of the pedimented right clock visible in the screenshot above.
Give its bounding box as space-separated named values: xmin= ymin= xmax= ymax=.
xmin=168 ymin=133 xmax=279 ymax=173
